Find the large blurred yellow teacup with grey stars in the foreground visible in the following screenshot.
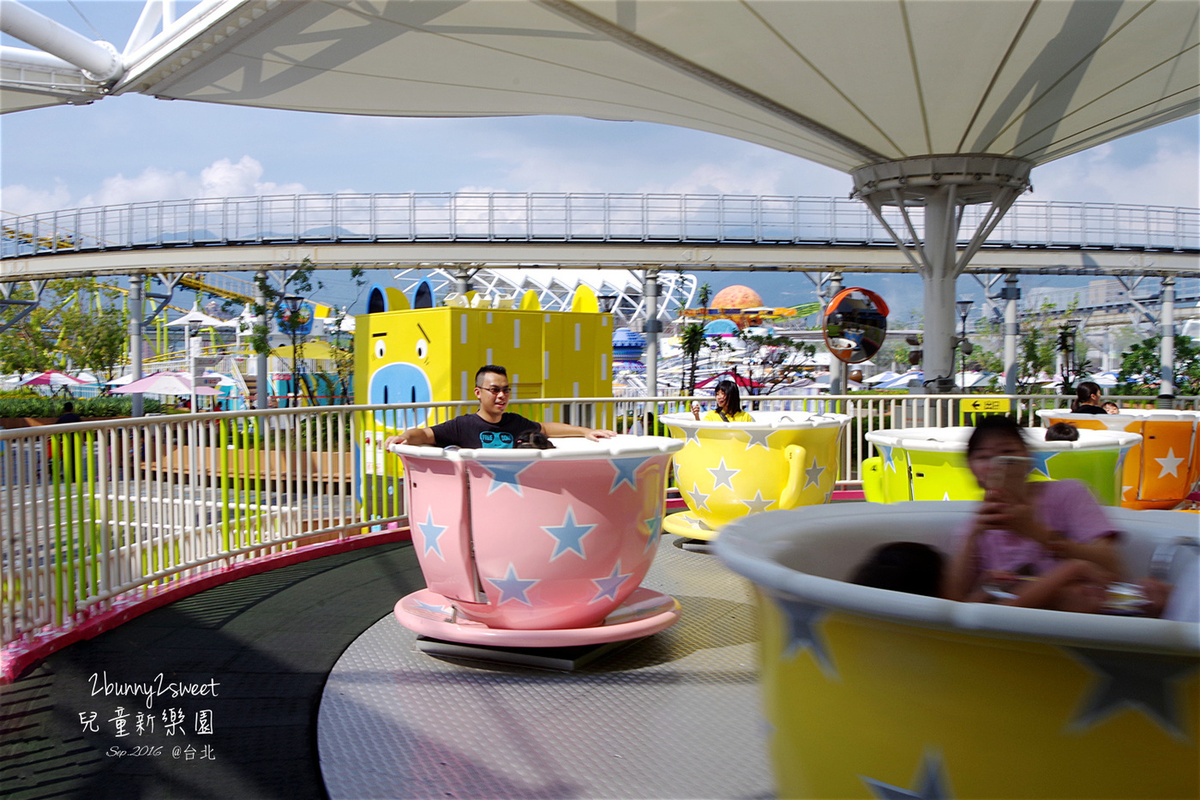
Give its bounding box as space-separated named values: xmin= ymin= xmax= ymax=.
xmin=715 ymin=501 xmax=1200 ymax=799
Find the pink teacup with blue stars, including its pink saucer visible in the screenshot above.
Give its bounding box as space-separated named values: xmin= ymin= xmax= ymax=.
xmin=391 ymin=435 xmax=683 ymax=648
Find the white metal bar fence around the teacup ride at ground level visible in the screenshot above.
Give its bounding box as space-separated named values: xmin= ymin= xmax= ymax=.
xmin=0 ymin=395 xmax=1200 ymax=671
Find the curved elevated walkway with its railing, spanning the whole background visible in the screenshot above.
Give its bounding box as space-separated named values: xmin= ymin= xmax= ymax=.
xmin=0 ymin=192 xmax=1200 ymax=282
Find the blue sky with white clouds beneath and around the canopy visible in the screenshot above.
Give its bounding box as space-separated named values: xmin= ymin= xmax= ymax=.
xmin=0 ymin=0 xmax=1200 ymax=319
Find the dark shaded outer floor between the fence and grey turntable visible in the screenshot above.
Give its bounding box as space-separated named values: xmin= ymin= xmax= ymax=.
xmin=0 ymin=545 xmax=424 ymax=800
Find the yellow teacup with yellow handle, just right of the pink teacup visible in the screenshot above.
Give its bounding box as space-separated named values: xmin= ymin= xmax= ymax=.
xmin=659 ymin=411 xmax=850 ymax=540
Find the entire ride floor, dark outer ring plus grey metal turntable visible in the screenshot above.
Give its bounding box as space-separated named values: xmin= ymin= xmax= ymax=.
xmin=0 ymin=536 xmax=770 ymax=800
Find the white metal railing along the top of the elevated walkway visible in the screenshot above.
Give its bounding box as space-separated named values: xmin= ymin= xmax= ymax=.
xmin=0 ymin=192 xmax=1200 ymax=258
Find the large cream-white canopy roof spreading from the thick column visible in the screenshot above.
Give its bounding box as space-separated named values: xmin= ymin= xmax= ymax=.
xmin=5 ymin=0 xmax=1200 ymax=172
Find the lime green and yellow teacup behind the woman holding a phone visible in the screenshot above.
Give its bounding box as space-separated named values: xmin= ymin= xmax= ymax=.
xmin=863 ymin=427 xmax=1141 ymax=506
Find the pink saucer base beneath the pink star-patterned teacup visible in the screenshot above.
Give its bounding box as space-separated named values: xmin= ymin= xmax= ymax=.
xmin=395 ymin=587 xmax=679 ymax=648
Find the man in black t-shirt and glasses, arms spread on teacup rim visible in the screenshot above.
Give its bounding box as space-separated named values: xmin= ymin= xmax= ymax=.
xmin=384 ymin=365 xmax=617 ymax=449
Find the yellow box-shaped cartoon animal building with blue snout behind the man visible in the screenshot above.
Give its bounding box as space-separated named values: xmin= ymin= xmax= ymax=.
xmin=354 ymin=282 xmax=613 ymax=525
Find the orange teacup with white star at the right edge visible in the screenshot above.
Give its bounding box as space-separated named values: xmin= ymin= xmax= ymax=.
xmin=1038 ymin=408 xmax=1200 ymax=509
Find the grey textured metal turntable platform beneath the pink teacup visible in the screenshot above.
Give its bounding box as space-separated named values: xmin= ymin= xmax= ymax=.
xmin=317 ymin=536 xmax=772 ymax=800
